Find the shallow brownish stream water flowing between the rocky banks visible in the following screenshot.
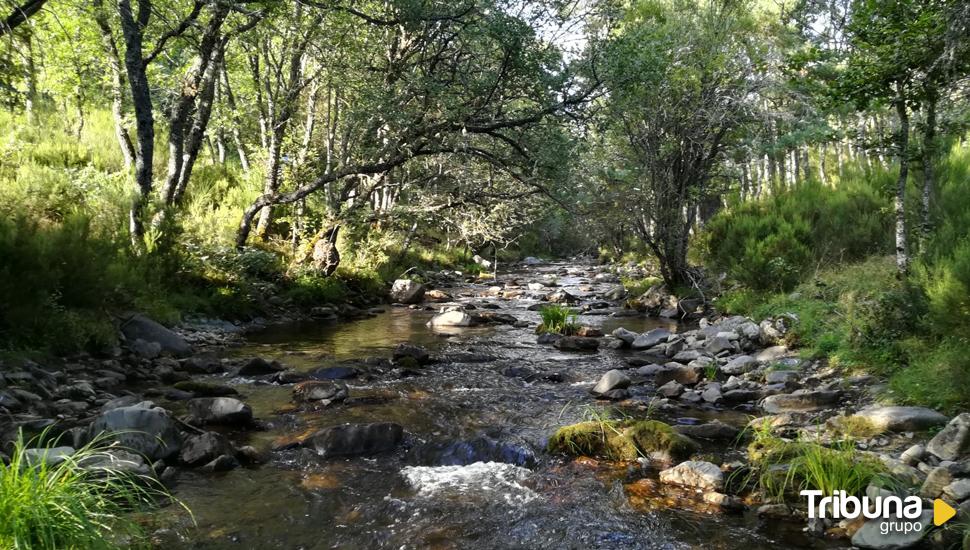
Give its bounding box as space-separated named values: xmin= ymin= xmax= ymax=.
xmin=157 ymin=264 xmax=824 ymax=550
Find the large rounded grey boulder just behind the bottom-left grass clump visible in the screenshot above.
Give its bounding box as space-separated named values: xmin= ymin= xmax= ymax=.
xmin=87 ymin=405 xmax=182 ymax=461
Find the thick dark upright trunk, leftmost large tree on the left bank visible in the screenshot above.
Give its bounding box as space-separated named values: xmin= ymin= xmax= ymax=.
xmin=118 ymin=0 xmax=155 ymax=247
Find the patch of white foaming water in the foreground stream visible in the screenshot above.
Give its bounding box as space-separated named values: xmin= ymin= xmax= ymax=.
xmin=401 ymin=462 xmax=538 ymax=504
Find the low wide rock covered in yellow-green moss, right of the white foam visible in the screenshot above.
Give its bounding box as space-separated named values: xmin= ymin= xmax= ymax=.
xmin=547 ymin=420 xmax=698 ymax=461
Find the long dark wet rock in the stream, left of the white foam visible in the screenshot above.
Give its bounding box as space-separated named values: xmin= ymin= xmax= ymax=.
xmin=304 ymin=422 xmax=404 ymax=458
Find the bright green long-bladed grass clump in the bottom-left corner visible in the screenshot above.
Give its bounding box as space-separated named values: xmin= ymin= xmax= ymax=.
xmin=0 ymin=436 xmax=177 ymax=550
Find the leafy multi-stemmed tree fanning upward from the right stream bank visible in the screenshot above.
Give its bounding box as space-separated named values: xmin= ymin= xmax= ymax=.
xmin=605 ymin=0 xmax=760 ymax=288
